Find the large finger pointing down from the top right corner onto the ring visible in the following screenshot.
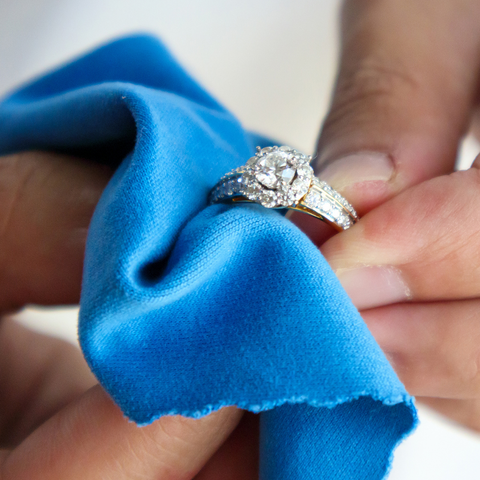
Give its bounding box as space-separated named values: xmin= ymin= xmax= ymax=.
xmin=318 ymin=0 xmax=480 ymax=214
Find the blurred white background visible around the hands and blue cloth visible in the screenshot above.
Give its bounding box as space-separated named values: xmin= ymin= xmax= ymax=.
xmin=0 ymin=0 xmax=480 ymax=474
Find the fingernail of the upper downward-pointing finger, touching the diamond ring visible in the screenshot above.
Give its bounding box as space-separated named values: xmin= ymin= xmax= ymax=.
xmin=318 ymin=152 xmax=394 ymax=190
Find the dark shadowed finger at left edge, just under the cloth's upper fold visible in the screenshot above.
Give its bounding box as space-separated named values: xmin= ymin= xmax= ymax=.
xmin=0 ymin=152 xmax=110 ymax=311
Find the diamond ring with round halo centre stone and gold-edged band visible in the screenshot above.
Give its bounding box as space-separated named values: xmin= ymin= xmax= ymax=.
xmin=209 ymin=146 xmax=358 ymax=230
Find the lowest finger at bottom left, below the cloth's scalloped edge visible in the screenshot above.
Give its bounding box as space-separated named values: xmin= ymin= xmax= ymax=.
xmin=0 ymin=386 xmax=242 ymax=480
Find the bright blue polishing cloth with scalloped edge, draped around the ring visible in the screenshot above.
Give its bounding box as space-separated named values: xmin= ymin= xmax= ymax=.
xmin=0 ymin=36 xmax=416 ymax=480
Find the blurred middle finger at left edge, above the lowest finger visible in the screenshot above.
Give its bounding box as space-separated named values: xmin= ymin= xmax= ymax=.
xmin=0 ymin=318 xmax=97 ymax=448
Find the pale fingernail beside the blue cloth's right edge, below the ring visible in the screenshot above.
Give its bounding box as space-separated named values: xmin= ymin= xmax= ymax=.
xmin=336 ymin=266 xmax=411 ymax=310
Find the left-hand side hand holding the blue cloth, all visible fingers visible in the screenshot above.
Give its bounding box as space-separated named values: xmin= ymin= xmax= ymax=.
xmin=0 ymin=153 xmax=258 ymax=480
